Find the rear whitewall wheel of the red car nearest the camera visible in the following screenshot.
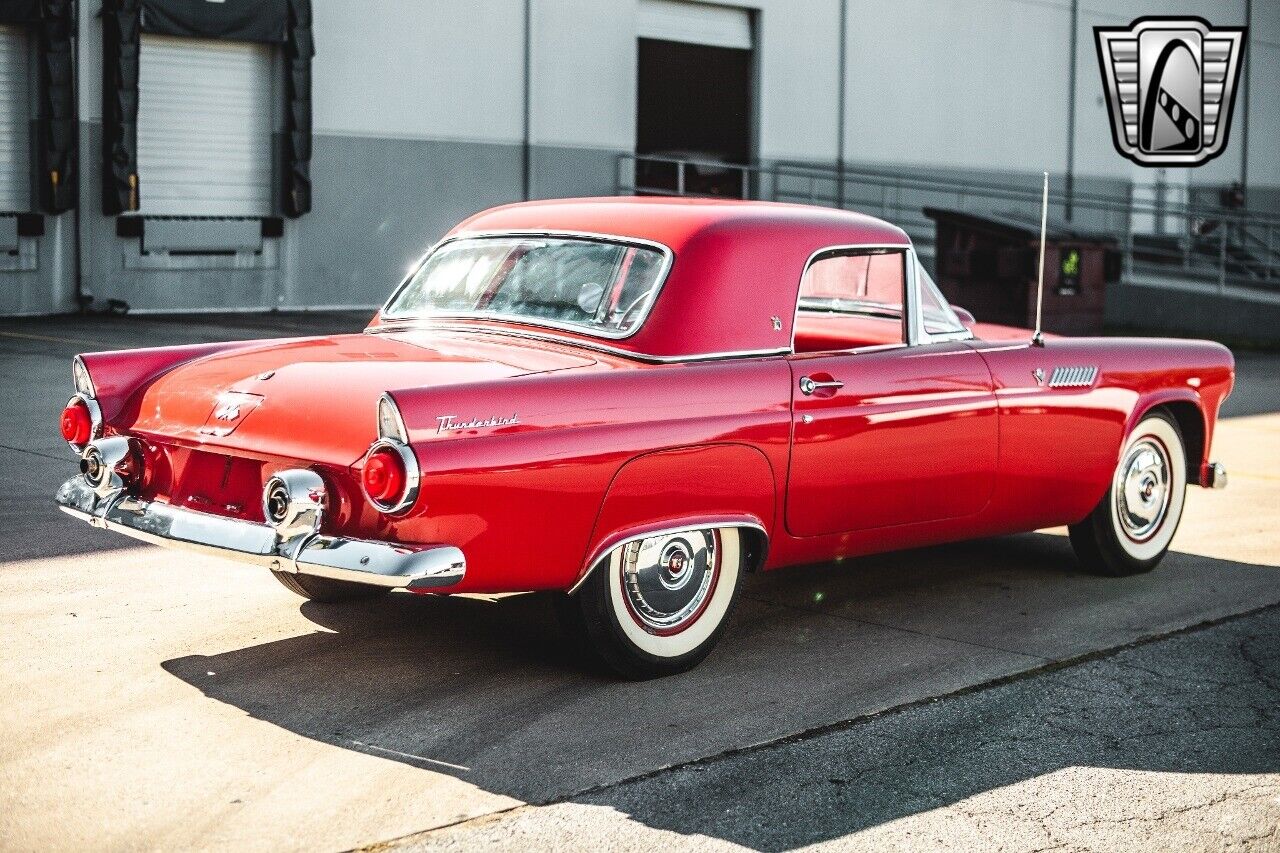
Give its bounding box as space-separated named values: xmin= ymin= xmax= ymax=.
xmin=558 ymin=528 xmax=742 ymax=680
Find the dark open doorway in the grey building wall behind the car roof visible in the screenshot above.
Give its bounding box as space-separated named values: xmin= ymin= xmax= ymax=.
xmin=636 ymin=38 xmax=751 ymax=197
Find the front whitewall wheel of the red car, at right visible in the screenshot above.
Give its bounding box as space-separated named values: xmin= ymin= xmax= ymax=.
xmin=1070 ymin=411 xmax=1187 ymax=578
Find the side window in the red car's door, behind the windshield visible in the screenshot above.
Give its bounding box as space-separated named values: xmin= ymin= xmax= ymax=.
xmin=796 ymin=251 xmax=906 ymax=352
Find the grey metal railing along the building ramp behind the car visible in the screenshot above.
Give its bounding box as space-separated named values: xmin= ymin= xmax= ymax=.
xmin=618 ymin=155 xmax=1280 ymax=291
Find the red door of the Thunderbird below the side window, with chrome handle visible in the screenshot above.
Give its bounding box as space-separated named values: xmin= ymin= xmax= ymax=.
xmin=786 ymin=343 xmax=997 ymax=537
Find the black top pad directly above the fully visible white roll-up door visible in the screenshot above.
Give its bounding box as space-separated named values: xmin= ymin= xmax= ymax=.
xmin=142 ymin=0 xmax=288 ymax=44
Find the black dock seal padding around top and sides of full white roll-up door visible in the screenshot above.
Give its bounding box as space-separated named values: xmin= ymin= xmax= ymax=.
xmin=98 ymin=0 xmax=315 ymax=216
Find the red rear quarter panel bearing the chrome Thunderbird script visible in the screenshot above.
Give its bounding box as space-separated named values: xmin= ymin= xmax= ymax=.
xmin=384 ymin=357 xmax=791 ymax=592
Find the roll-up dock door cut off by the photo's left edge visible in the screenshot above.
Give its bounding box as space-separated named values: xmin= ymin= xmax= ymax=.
xmin=0 ymin=26 xmax=31 ymax=213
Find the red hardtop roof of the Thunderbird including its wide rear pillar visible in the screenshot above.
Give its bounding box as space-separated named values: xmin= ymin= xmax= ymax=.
xmin=435 ymin=197 xmax=910 ymax=361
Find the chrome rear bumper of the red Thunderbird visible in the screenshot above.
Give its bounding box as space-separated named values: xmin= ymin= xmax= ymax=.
xmin=54 ymin=475 xmax=466 ymax=589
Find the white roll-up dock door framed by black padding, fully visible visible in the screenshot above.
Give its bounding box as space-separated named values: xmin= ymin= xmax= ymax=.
xmin=138 ymin=35 xmax=275 ymax=216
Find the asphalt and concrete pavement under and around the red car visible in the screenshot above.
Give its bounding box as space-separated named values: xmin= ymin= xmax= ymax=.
xmin=0 ymin=315 xmax=1280 ymax=850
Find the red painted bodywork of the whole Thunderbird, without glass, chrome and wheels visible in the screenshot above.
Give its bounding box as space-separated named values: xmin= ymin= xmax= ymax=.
xmin=67 ymin=200 xmax=1233 ymax=592
